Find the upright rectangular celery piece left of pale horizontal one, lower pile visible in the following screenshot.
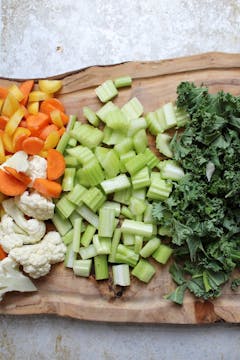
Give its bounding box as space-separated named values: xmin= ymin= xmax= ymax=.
xmin=98 ymin=207 xmax=115 ymax=237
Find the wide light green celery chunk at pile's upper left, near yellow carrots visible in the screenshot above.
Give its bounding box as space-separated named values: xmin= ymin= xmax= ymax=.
xmin=70 ymin=124 xmax=103 ymax=149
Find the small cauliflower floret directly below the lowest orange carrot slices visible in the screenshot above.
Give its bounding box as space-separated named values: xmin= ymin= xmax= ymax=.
xmin=15 ymin=191 xmax=55 ymax=220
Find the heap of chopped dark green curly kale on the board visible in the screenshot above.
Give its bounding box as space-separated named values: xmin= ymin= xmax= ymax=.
xmin=153 ymin=82 xmax=240 ymax=304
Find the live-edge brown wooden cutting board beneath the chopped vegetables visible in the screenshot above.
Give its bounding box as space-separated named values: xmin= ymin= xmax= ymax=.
xmin=0 ymin=53 xmax=240 ymax=324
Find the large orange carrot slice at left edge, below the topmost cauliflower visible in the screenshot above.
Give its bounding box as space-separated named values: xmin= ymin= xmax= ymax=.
xmin=0 ymin=169 xmax=27 ymax=196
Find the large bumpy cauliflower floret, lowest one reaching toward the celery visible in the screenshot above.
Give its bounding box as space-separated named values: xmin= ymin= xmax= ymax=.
xmin=9 ymin=231 xmax=66 ymax=279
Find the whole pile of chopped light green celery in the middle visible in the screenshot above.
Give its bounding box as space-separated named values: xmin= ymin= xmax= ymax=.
xmin=53 ymin=76 xmax=188 ymax=286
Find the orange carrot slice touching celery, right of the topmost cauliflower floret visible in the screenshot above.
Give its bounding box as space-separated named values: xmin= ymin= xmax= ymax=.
xmin=47 ymin=149 xmax=66 ymax=180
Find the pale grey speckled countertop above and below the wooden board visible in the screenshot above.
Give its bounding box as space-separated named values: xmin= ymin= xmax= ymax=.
xmin=0 ymin=0 xmax=240 ymax=360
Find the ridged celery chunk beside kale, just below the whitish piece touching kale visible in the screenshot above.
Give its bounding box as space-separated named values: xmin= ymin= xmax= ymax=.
xmin=147 ymin=172 xmax=172 ymax=200
